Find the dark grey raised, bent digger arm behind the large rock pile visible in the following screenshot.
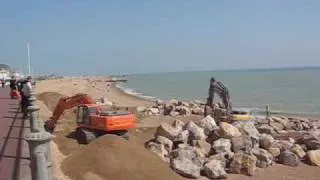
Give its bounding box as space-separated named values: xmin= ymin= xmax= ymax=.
xmin=207 ymin=77 xmax=232 ymax=114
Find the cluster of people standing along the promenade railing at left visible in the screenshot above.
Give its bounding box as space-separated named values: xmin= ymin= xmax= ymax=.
xmin=10 ymin=76 xmax=33 ymax=119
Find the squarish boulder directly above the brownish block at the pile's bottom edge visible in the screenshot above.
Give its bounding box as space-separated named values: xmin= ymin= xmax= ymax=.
xmin=231 ymin=136 xmax=253 ymax=153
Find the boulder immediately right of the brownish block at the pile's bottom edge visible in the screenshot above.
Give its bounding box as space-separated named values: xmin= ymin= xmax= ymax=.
xmin=252 ymin=148 xmax=273 ymax=168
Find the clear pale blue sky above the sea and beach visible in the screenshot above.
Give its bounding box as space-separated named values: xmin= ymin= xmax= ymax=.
xmin=0 ymin=0 xmax=320 ymax=75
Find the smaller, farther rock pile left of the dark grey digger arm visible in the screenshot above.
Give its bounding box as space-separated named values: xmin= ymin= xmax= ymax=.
xmin=137 ymin=99 xmax=204 ymax=116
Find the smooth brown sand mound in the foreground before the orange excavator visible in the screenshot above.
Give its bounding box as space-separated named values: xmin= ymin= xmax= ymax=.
xmin=62 ymin=135 xmax=182 ymax=180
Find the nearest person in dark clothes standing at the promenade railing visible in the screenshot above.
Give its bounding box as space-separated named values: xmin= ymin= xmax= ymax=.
xmin=21 ymin=76 xmax=32 ymax=119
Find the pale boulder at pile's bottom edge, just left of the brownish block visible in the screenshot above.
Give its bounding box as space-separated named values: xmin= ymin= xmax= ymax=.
xmin=203 ymin=159 xmax=227 ymax=179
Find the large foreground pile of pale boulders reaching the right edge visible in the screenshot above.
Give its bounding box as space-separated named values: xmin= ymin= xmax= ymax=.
xmin=145 ymin=116 xmax=320 ymax=179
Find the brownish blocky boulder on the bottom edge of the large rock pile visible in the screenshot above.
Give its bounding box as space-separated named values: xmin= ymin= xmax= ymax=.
xmin=229 ymin=152 xmax=257 ymax=176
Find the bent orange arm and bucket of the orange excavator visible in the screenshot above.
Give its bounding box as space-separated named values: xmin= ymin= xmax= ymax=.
xmin=44 ymin=94 xmax=95 ymax=132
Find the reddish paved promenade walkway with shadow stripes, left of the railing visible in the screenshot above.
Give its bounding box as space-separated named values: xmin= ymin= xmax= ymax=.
xmin=0 ymin=87 xmax=31 ymax=180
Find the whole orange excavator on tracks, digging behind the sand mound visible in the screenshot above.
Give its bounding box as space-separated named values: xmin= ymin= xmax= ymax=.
xmin=44 ymin=94 xmax=136 ymax=144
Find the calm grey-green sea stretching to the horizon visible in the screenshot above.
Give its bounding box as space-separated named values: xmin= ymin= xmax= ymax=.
xmin=119 ymin=67 xmax=320 ymax=117
